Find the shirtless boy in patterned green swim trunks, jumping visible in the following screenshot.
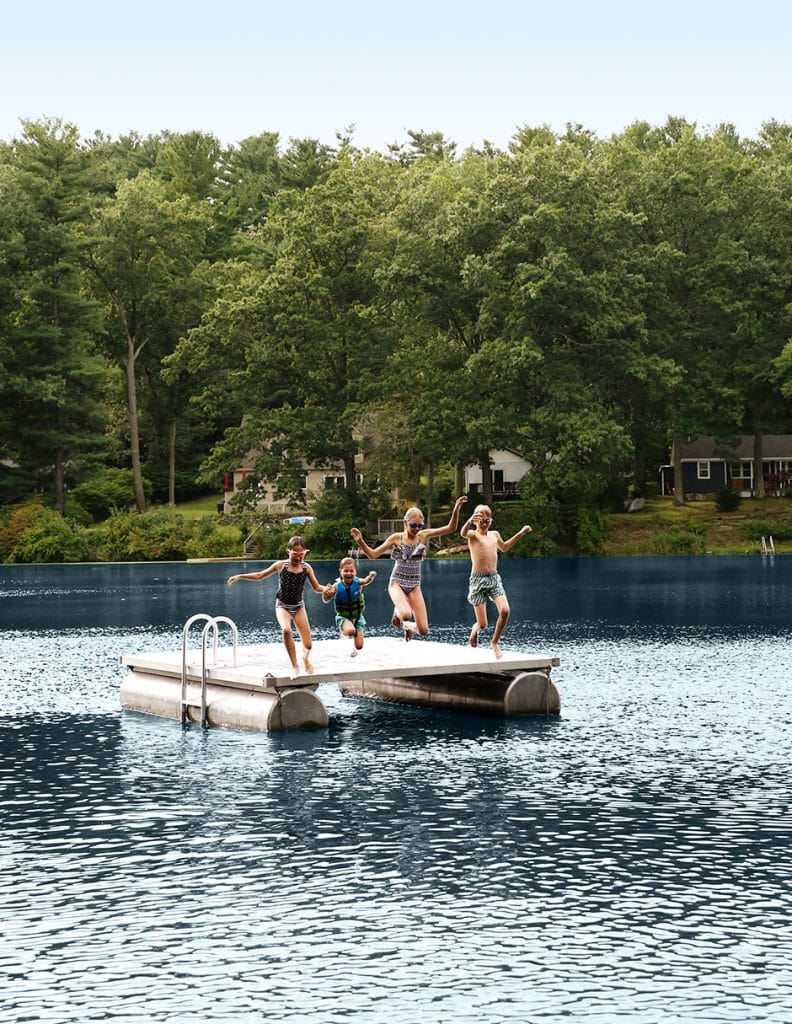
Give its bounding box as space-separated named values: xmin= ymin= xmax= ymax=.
xmin=460 ymin=505 xmax=531 ymax=657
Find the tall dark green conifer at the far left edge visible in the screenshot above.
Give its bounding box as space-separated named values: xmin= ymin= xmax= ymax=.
xmin=0 ymin=120 xmax=106 ymax=514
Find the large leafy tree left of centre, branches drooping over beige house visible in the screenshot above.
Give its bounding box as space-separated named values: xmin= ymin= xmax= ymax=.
xmin=186 ymin=151 xmax=400 ymax=507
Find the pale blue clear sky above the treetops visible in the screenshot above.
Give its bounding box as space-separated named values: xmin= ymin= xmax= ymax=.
xmin=0 ymin=0 xmax=792 ymax=152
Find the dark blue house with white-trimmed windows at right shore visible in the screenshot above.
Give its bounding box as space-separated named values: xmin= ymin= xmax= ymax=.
xmin=660 ymin=434 xmax=792 ymax=498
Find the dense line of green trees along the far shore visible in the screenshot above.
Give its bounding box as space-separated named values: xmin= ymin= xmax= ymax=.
xmin=0 ymin=119 xmax=792 ymax=552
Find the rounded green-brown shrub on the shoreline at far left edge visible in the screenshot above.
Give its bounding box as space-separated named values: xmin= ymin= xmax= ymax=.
xmin=0 ymin=503 xmax=89 ymax=563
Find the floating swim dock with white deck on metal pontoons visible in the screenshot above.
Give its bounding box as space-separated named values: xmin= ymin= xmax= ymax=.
xmin=121 ymin=621 xmax=560 ymax=732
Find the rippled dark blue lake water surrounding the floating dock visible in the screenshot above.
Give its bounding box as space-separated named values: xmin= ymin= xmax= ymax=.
xmin=0 ymin=556 xmax=792 ymax=1024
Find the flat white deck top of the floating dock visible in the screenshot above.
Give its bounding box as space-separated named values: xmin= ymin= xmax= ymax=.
xmin=121 ymin=637 xmax=559 ymax=691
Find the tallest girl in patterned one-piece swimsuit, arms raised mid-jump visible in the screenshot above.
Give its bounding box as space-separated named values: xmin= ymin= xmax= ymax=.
xmin=351 ymin=495 xmax=467 ymax=640
